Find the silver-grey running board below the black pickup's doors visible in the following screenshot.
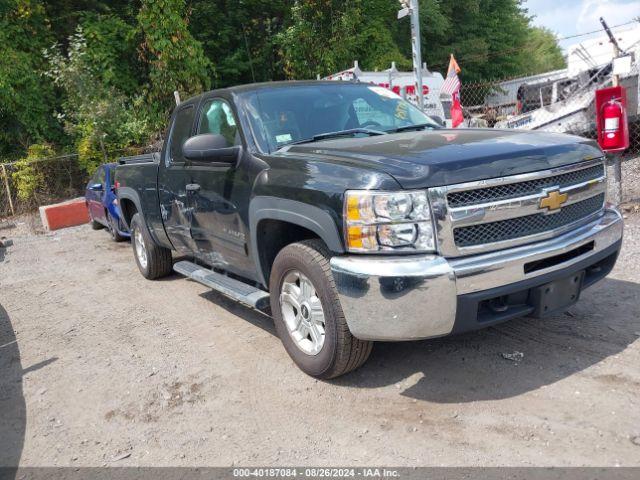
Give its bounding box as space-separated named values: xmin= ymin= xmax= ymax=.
xmin=173 ymin=261 xmax=269 ymax=310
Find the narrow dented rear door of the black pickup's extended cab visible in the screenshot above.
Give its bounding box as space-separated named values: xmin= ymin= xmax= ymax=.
xmin=158 ymin=104 xmax=196 ymax=253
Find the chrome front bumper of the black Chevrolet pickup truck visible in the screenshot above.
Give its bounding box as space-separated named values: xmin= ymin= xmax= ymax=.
xmin=331 ymin=209 xmax=623 ymax=341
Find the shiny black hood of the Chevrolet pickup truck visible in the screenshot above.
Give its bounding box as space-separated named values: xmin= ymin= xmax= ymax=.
xmin=281 ymin=129 xmax=603 ymax=188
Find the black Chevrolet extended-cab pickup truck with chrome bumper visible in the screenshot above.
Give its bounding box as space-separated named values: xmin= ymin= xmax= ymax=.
xmin=116 ymin=82 xmax=623 ymax=378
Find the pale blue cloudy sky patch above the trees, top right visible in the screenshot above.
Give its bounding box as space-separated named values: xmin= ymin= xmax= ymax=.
xmin=523 ymin=0 xmax=640 ymax=49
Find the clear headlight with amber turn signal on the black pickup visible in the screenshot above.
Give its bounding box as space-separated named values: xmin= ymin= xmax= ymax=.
xmin=344 ymin=190 xmax=435 ymax=252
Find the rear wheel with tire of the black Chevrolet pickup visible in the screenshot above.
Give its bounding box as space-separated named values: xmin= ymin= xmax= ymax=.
xmin=131 ymin=213 xmax=173 ymax=280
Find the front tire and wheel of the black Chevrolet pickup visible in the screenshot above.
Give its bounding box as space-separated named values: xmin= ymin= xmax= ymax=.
xmin=269 ymin=239 xmax=373 ymax=379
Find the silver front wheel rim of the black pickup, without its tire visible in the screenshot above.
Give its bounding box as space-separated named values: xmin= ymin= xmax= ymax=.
xmin=280 ymin=270 xmax=325 ymax=355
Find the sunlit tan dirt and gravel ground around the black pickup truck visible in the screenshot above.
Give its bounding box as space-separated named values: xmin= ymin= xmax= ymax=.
xmin=0 ymin=212 xmax=640 ymax=466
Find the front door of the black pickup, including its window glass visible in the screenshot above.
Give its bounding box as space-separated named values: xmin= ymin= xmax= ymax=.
xmin=187 ymin=98 xmax=253 ymax=276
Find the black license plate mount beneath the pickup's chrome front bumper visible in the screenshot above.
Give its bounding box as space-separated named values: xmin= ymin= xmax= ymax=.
xmin=529 ymin=270 xmax=585 ymax=318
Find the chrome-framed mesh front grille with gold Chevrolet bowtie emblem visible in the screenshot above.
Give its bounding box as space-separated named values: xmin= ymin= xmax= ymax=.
xmin=429 ymin=159 xmax=606 ymax=257
